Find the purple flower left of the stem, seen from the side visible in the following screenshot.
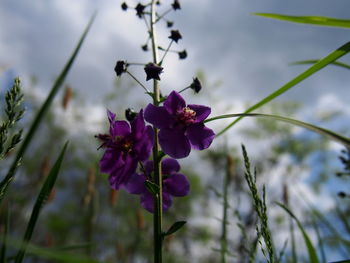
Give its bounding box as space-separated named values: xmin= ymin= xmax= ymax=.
xmin=96 ymin=110 xmax=153 ymax=190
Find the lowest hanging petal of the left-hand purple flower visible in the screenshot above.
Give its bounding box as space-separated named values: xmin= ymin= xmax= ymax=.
xmin=108 ymin=156 xmax=137 ymax=190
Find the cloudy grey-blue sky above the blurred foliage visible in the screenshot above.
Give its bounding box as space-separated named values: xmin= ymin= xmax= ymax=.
xmin=0 ymin=0 xmax=350 ymax=262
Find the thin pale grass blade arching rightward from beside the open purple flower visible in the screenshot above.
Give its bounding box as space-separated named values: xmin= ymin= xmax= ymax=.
xmin=204 ymin=113 xmax=350 ymax=148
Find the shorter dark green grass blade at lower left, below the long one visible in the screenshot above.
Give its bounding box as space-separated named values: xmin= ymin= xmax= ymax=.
xmin=15 ymin=142 xmax=68 ymax=263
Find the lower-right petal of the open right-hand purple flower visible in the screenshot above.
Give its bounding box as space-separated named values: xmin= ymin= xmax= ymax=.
xmin=187 ymin=123 xmax=215 ymax=150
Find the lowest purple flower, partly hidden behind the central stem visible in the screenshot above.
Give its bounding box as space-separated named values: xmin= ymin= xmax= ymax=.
xmin=126 ymin=158 xmax=190 ymax=213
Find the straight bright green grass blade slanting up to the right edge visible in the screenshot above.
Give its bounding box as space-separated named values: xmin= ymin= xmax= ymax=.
xmin=216 ymin=42 xmax=350 ymax=137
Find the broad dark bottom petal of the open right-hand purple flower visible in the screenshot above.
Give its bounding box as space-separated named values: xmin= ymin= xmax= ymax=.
xmin=158 ymin=128 xmax=191 ymax=159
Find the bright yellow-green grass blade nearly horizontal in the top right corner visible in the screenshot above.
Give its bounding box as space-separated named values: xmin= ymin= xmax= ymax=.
xmin=253 ymin=13 xmax=350 ymax=28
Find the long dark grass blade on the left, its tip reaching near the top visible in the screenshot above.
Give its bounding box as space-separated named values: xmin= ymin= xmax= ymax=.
xmin=0 ymin=13 xmax=96 ymax=203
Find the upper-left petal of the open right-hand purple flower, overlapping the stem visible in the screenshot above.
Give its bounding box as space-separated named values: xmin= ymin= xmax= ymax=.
xmin=145 ymin=104 xmax=175 ymax=129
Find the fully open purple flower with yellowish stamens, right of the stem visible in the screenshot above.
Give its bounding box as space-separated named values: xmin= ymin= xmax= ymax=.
xmin=145 ymin=91 xmax=215 ymax=159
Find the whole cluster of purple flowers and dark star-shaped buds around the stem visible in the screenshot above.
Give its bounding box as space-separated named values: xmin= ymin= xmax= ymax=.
xmin=96 ymin=0 xmax=215 ymax=212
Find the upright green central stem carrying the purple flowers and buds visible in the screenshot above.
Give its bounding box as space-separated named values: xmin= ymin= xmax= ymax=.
xmin=150 ymin=0 xmax=163 ymax=263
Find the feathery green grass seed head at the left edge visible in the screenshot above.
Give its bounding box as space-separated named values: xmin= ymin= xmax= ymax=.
xmin=0 ymin=78 xmax=24 ymax=160
